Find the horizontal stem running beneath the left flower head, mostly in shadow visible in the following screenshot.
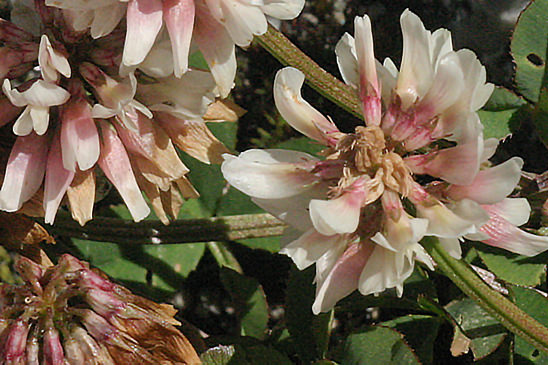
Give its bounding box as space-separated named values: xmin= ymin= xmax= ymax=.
xmin=48 ymin=210 xmax=285 ymax=244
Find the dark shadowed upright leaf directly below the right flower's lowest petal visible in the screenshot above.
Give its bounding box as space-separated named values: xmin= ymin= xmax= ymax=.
xmin=285 ymin=266 xmax=331 ymax=363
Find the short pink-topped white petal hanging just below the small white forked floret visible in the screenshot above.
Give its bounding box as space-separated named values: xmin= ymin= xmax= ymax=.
xmin=61 ymin=99 xmax=100 ymax=172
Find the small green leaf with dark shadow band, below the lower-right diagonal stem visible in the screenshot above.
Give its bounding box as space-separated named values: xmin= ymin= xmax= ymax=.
xmin=445 ymin=298 xmax=506 ymax=360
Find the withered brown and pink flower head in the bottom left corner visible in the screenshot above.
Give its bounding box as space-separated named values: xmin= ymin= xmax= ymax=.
xmin=0 ymin=255 xmax=200 ymax=364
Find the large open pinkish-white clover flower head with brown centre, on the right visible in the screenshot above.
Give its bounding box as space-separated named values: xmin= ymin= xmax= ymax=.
xmin=222 ymin=11 xmax=548 ymax=313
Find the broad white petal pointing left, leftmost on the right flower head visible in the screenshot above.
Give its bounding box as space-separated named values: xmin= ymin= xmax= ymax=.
xmin=221 ymin=150 xmax=319 ymax=199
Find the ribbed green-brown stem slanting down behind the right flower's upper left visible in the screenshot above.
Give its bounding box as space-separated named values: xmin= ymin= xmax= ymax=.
xmin=255 ymin=26 xmax=363 ymax=119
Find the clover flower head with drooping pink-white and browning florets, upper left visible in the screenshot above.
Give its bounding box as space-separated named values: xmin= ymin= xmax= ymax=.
xmin=0 ymin=0 xmax=231 ymax=224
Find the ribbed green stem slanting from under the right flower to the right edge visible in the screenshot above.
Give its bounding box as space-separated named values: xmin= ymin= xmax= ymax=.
xmin=422 ymin=237 xmax=548 ymax=353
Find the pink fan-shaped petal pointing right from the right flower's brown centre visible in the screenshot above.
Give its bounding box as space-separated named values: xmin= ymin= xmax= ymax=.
xmin=404 ymin=135 xmax=483 ymax=185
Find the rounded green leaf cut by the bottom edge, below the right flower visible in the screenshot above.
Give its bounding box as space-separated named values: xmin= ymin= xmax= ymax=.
xmin=341 ymin=326 xmax=419 ymax=364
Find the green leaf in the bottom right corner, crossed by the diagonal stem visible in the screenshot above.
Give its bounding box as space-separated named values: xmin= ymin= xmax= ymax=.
xmin=509 ymin=286 xmax=548 ymax=364
